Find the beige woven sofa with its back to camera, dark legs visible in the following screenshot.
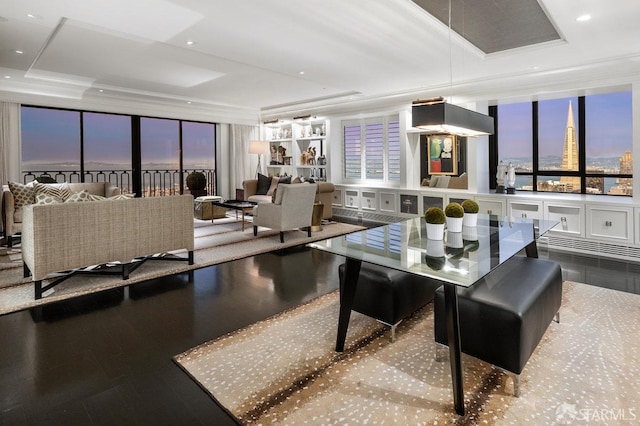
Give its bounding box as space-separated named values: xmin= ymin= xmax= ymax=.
xmin=22 ymin=195 xmax=194 ymax=298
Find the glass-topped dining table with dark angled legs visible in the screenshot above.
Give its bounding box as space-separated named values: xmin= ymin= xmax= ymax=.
xmin=309 ymin=214 xmax=557 ymax=415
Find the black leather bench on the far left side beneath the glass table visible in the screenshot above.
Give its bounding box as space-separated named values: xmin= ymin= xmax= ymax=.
xmin=338 ymin=262 xmax=441 ymax=340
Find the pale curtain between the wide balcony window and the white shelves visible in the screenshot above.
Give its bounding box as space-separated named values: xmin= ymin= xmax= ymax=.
xmin=229 ymin=124 xmax=260 ymax=194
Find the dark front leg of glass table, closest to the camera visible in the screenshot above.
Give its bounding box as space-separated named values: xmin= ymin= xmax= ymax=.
xmin=444 ymin=284 xmax=464 ymax=416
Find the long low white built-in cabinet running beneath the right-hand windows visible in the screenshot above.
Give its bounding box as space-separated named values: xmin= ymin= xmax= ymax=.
xmin=334 ymin=185 xmax=640 ymax=261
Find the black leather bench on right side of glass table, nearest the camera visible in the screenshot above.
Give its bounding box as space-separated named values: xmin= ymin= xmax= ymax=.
xmin=434 ymin=256 xmax=562 ymax=396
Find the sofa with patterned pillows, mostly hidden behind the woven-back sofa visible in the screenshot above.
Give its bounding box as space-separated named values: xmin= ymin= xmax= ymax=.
xmin=2 ymin=182 xmax=120 ymax=247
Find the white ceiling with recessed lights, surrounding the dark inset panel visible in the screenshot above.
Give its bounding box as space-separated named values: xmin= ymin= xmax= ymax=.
xmin=0 ymin=0 xmax=640 ymax=122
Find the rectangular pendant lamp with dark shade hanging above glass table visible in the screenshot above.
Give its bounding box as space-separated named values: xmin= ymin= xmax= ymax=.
xmin=411 ymin=102 xmax=494 ymax=137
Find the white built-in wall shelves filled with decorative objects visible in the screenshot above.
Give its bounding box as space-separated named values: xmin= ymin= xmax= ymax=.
xmin=263 ymin=119 xmax=328 ymax=181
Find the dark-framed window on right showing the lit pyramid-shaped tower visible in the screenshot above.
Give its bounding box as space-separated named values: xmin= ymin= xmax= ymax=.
xmin=492 ymin=91 xmax=633 ymax=196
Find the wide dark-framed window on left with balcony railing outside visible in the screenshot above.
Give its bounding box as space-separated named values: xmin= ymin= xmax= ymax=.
xmin=22 ymin=106 xmax=216 ymax=196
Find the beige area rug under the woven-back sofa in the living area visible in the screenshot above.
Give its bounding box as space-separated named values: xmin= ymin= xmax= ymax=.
xmin=0 ymin=218 xmax=364 ymax=315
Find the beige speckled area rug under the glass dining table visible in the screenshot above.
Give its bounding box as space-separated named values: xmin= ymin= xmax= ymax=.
xmin=174 ymin=282 xmax=640 ymax=425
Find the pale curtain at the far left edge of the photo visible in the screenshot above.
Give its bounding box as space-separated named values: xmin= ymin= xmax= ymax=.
xmin=0 ymin=102 xmax=22 ymax=185
